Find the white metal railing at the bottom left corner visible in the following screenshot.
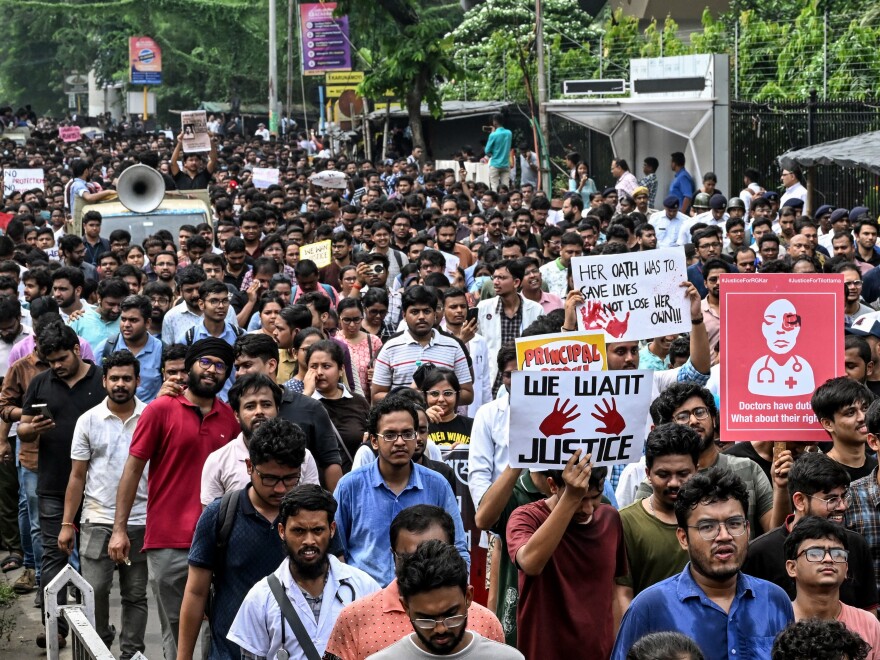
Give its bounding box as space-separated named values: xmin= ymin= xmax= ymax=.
xmin=43 ymin=564 xmax=147 ymax=660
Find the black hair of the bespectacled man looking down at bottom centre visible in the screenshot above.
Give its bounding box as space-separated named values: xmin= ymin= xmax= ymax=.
xmin=397 ymin=540 xmax=469 ymax=598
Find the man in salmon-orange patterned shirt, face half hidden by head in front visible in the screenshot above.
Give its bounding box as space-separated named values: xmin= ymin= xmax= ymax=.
xmin=324 ymin=504 xmax=504 ymax=660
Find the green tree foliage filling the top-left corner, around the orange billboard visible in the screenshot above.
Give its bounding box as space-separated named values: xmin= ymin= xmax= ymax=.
xmin=0 ymin=0 xmax=285 ymax=113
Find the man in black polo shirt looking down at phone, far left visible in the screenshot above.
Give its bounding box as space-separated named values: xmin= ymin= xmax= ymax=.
xmin=18 ymin=322 xmax=105 ymax=648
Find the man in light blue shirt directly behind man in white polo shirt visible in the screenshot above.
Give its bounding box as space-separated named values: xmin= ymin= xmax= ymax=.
xmin=96 ymin=296 xmax=162 ymax=403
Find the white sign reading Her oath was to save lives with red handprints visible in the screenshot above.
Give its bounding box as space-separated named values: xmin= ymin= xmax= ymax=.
xmin=571 ymin=248 xmax=691 ymax=342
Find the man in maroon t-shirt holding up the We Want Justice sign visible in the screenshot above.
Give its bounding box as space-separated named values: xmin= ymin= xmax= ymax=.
xmin=504 ymin=449 xmax=627 ymax=660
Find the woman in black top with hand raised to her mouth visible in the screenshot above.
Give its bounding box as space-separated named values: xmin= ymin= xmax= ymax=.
xmin=305 ymin=339 xmax=370 ymax=472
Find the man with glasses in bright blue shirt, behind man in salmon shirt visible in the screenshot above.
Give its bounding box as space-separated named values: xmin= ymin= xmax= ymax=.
xmin=334 ymin=395 xmax=470 ymax=587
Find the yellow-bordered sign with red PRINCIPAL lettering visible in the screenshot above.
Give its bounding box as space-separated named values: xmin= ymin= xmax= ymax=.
xmin=516 ymin=332 xmax=608 ymax=371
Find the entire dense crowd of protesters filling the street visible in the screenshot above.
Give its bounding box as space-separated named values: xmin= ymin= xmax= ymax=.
xmin=0 ymin=107 xmax=880 ymax=660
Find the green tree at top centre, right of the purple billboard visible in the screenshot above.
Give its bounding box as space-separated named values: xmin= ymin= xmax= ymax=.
xmin=336 ymin=0 xmax=461 ymax=149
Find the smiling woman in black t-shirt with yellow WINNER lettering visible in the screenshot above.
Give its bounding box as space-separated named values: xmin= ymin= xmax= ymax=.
xmin=413 ymin=364 xmax=474 ymax=449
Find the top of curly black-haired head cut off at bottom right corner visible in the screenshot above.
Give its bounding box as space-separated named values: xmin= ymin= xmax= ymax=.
xmin=770 ymin=619 xmax=871 ymax=660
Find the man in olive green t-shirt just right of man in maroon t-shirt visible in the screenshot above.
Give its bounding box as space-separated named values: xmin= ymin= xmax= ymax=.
xmin=617 ymin=424 xmax=700 ymax=602
